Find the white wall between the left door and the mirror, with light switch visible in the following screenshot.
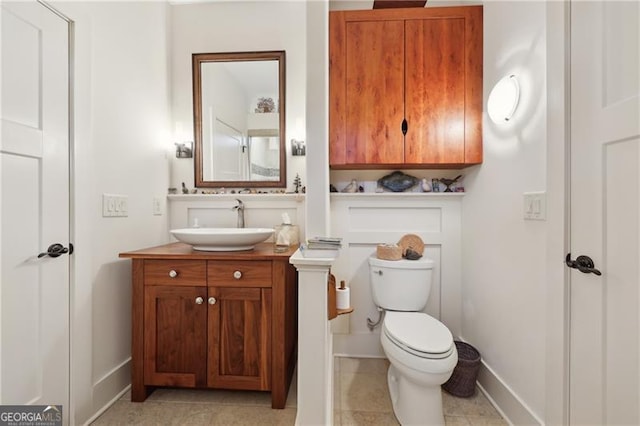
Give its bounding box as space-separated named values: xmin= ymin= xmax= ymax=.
xmin=53 ymin=2 xmax=171 ymax=424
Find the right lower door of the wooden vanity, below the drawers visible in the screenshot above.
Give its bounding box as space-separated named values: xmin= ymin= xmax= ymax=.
xmin=207 ymin=287 xmax=271 ymax=390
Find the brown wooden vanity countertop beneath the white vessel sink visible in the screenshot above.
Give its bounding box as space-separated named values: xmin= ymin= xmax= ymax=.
xmin=119 ymin=243 xmax=298 ymax=260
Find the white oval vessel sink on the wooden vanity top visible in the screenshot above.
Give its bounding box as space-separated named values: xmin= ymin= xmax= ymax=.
xmin=169 ymin=228 xmax=273 ymax=251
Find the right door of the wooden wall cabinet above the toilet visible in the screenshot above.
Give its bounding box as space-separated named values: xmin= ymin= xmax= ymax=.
xmin=404 ymin=18 xmax=465 ymax=164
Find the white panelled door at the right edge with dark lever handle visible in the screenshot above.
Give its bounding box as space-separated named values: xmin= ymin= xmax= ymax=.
xmin=569 ymin=1 xmax=640 ymax=425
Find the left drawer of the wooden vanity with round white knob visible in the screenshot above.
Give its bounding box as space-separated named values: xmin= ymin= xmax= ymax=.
xmin=144 ymin=260 xmax=207 ymax=286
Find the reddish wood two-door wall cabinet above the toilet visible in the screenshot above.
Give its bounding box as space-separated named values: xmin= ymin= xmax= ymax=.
xmin=329 ymin=6 xmax=482 ymax=169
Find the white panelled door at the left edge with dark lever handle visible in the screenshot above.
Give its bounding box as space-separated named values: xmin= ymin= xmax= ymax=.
xmin=0 ymin=2 xmax=70 ymax=423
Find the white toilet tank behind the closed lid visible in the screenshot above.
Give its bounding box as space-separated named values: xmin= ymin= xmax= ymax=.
xmin=369 ymin=255 xmax=433 ymax=311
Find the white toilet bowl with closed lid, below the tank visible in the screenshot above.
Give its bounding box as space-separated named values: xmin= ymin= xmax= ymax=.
xmin=380 ymin=312 xmax=458 ymax=425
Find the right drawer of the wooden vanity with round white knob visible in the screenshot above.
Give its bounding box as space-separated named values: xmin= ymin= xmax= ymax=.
xmin=207 ymin=260 xmax=271 ymax=287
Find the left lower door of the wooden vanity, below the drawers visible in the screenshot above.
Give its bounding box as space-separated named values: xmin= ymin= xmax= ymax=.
xmin=144 ymin=286 xmax=207 ymax=387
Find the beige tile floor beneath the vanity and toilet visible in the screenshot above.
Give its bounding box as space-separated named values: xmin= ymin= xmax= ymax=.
xmin=92 ymin=358 xmax=507 ymax=426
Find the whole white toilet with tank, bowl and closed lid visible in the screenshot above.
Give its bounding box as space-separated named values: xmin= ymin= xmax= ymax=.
xmin=369 ymin=255 xmax=458 ymax=425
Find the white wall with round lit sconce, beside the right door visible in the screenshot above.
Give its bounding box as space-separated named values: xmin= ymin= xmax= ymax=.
xmin=462 ymin=2 xmax=548 ymax=420
